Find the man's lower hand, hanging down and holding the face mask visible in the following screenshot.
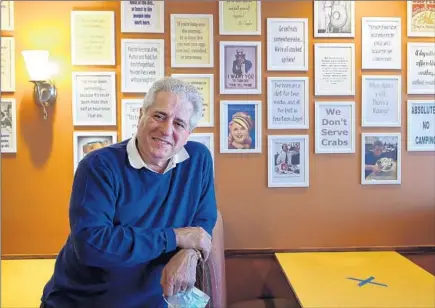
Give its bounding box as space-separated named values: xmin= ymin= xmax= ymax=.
xmin=160 ymin=249 xmax=199 ymax=296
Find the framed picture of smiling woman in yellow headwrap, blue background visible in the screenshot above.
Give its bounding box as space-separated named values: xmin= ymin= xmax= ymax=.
xmin=220 ymin=100 xmax=262 ymax=154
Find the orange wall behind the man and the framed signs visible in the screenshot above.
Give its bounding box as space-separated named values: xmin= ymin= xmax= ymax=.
xmin=1 ymin=1 xmax=435 ymax=254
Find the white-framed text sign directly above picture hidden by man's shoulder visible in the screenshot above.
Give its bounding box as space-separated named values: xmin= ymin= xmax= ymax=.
xmin=72 ymin=72 xmax=116 ymax=126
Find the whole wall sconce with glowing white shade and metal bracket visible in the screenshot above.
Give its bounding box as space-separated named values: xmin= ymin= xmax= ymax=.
xmin=21 ymin=50 xmax=57 ymax=120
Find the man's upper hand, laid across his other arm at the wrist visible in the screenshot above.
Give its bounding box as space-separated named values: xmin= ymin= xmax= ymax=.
xmin=174 ymin=227 xmax=212 ymax=261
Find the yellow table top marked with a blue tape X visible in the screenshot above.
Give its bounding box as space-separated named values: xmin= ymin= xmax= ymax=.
xmin=275 ymin=251 xmax=435 ymax=308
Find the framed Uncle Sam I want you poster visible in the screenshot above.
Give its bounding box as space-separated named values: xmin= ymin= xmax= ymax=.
xmin=219 ymin=41 xmax=261 ymax=94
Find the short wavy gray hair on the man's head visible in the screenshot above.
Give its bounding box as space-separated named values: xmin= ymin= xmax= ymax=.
xmin=143 ymin=77 xmax=204 ymax=131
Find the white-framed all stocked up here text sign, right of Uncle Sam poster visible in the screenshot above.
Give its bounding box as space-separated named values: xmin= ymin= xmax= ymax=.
xmin=267 ymin=18 xmax=309 ymax=71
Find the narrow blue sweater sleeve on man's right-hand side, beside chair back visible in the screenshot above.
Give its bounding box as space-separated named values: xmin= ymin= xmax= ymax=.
xmin=193 ymin=150 xmax=217 ymax=236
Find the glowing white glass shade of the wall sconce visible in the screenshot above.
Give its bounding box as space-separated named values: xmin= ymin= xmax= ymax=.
xmin=21 ymin=50 xmax=51 ymax=81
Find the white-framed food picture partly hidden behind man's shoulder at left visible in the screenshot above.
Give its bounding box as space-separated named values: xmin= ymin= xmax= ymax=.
xmin=73 ymin=131 xmax=118 ymax=172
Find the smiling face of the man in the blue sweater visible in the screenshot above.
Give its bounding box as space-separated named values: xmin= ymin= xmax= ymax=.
xmin=137 ymin=92 xmax=193 ymax=165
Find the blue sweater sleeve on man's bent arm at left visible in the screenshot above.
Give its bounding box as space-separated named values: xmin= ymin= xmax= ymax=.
xmin=70 ymin=155 xmax=176 ymax=267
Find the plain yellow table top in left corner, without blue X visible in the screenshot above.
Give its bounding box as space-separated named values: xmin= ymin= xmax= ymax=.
xmin=0 ymin=259 xmax=56 ymax=308
